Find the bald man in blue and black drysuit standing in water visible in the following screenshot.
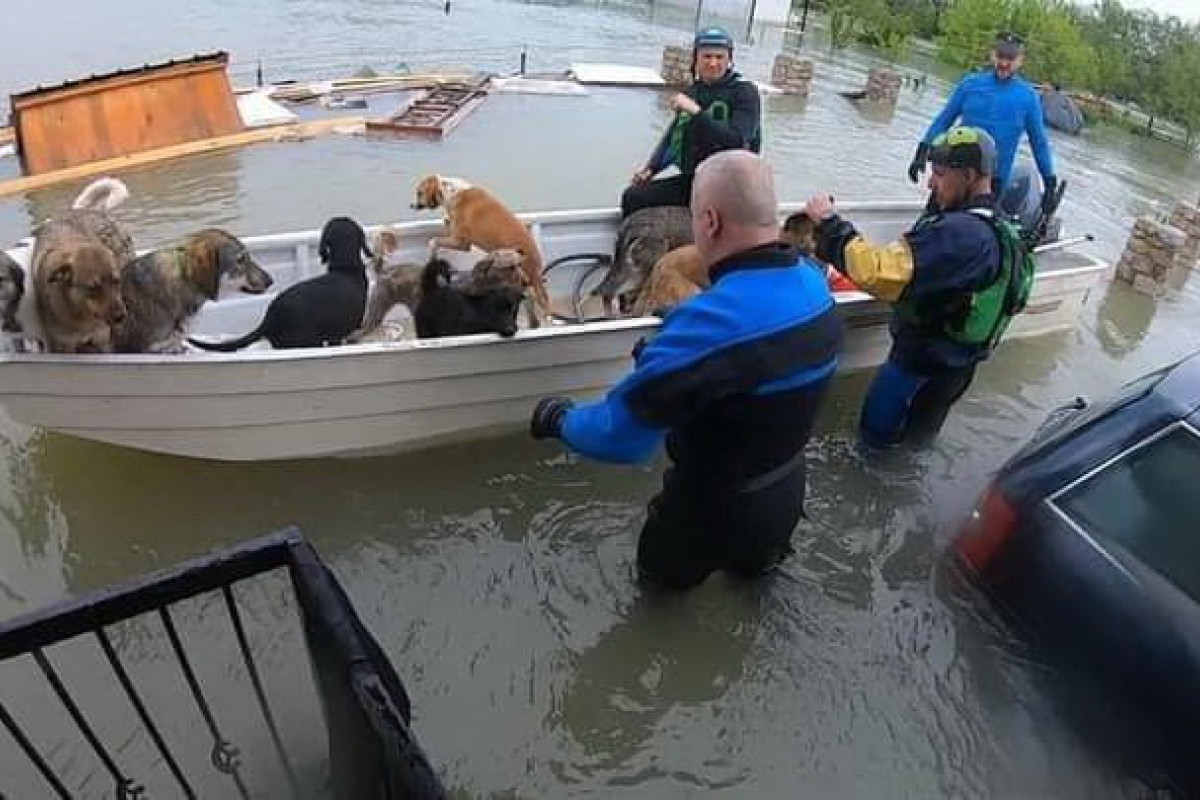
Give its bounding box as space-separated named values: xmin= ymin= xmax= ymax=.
xmin=530 ymin=150 xmax=842 ymax=589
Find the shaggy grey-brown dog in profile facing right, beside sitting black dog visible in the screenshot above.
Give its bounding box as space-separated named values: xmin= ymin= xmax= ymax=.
xmin=113 ymin=228 xmax=272 ymax=353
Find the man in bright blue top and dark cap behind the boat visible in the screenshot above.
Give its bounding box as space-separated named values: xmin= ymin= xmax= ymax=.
xmin=908 ymin=32 xmax=1058 ymax=207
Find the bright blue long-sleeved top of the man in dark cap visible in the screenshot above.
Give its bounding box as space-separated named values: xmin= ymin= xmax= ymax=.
xmin=923 ymin=70 xmax=1055 ymax=188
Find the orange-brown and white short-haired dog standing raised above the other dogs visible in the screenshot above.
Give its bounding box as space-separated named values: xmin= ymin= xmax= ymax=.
xmin=413 ymin=174 xmax=551 ymax=327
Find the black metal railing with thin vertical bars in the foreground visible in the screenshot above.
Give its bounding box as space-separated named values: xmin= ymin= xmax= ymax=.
xmin=0 ymin=529 xmax=444 ymax=800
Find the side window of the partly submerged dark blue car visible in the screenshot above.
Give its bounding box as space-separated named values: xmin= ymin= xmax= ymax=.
xmin=1052 ymin=426 xmax=1200 ymax=600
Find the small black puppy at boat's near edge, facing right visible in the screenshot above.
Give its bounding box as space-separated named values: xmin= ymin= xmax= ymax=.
xmin=413 ymin=258 xmax=524 ymax=339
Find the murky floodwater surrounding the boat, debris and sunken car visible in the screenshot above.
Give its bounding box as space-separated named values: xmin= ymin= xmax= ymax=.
xmin=0 ymin=0 xmax=1200 ymax=798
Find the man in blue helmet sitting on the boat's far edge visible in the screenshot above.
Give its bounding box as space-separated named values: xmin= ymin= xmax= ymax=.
xmin=620 ymin=28 xmax=762 ymax=217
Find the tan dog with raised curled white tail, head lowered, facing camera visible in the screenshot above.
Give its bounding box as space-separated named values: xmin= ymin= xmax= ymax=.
xmin=30 ymin=178 xmax=134 ymax=353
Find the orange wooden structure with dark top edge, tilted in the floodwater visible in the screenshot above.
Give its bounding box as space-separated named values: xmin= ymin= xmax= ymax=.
xmin=12 ymin=52 xmax=245 ymax=175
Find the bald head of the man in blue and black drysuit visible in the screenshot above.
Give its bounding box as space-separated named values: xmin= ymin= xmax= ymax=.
xmin=691 ymin=150 xmax=779 ymax=265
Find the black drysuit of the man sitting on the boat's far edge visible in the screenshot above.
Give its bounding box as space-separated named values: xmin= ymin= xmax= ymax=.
xmin=620 ymin=70 xmax=762 ymax=217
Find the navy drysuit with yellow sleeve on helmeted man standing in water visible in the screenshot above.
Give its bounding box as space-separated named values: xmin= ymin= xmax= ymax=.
xmin=816 ymin=196 xmax=1002 ymax=447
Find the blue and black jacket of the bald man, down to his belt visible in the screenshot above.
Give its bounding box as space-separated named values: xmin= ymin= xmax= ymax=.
xmin=562 ymin=243 xmax=842 ymax=487
